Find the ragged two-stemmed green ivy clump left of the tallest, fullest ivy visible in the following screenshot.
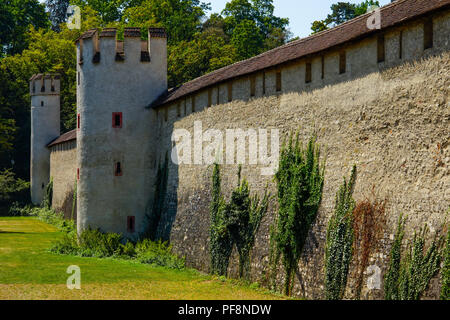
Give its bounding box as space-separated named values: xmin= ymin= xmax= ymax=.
xmin=210 ymin=164 xmax=269 ymax=280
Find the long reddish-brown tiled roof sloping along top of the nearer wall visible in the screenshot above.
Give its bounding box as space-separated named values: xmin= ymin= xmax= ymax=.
xmin=150 ymin=0 xmax=450 ymax=108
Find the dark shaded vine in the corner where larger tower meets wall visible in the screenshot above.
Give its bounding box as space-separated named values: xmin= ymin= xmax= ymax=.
xmin=145 ymin=153 xmax=169 ymax=241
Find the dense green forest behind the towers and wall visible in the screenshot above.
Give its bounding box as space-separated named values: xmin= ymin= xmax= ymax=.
xmin=0 ymin=0 xmax=378 ymax=207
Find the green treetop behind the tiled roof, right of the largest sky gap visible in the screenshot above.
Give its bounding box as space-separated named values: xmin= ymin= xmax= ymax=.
xmin=311 ymin=0 xmax=380 ymax=34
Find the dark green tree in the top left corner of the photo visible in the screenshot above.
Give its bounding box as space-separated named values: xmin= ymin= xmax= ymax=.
xmin=0 ymin=0 xmax=49 ymax=56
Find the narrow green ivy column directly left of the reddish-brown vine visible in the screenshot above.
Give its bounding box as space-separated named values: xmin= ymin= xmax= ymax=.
xmin=325 ymin=166 xmax=356 ymax=300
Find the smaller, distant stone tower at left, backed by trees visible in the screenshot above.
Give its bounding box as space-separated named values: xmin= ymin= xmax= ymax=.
xmin=30 ymin=74 xmax=60 ymax=204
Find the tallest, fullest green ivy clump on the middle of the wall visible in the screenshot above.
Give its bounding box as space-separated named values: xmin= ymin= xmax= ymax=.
xmin=271 ymin=133 xmax=325 ymax=295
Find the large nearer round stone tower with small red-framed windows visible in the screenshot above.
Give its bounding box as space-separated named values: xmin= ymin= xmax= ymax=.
xmin=77 ymin=28 xmax=167 ymax=238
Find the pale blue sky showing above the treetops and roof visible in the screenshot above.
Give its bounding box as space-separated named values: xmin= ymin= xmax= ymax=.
xmin=209 ymin=0 xmax=391 ymax=38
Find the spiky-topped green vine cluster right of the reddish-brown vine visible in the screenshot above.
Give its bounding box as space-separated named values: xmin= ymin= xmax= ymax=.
xmin=385 ymin=217 xmax=444 ymax=300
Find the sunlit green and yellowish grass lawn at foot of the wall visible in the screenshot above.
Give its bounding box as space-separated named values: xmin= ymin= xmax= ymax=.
xmin=0 ymin=217 xmax=282 ymax=300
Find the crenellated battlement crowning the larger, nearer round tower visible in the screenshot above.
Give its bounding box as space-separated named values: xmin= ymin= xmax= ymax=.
xmin=76 ymin=28 xmax=167 ymax=65
